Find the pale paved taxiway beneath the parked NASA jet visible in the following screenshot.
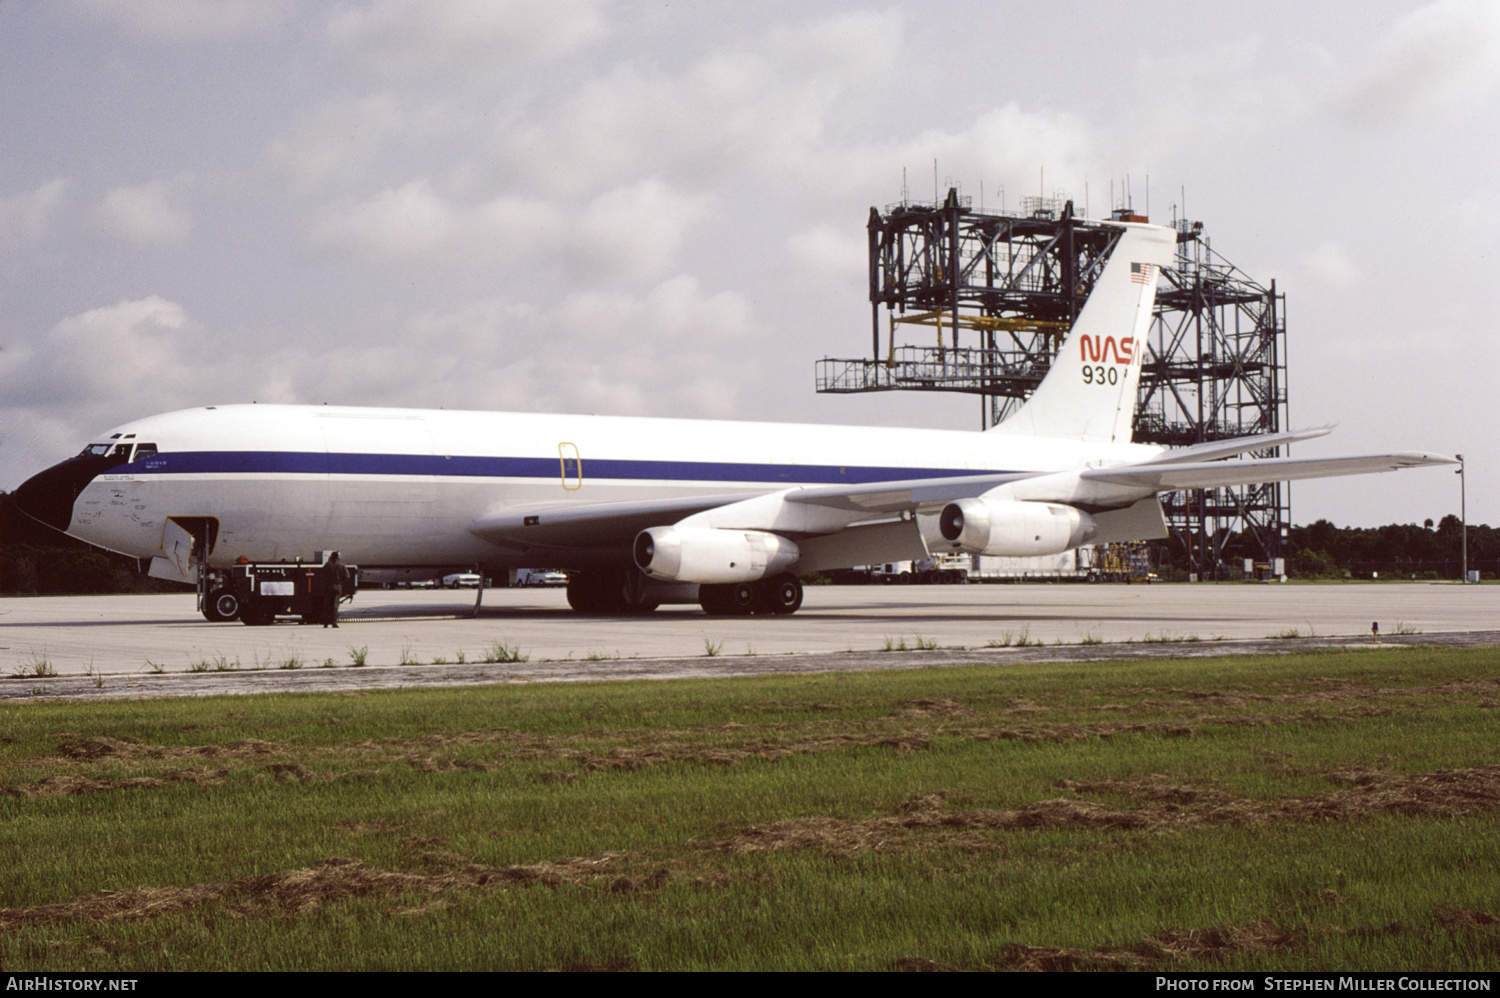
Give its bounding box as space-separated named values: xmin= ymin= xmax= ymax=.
xmin=0 ymin=582 xmax=1500 ymax=699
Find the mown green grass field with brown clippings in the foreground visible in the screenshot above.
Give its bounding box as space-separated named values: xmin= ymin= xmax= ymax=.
xmin=0 ymin=648 xmax=1500 ymax=971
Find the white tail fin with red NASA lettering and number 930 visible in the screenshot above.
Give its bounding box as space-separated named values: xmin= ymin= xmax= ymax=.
xmin=992 ymin=222 xmax=1178 ymax=443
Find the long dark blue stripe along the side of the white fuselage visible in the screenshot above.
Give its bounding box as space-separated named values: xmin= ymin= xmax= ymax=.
xmin=126 ymin=450 xmax=998 ymax=485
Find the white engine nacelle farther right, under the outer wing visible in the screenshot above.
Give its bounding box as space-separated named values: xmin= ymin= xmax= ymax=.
xmin=938 ymin=498 xmax=1100 ymax=558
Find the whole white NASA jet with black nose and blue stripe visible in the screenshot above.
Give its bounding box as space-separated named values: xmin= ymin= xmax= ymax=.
xmin=15 ymin=224 xmax=1452 ymax=614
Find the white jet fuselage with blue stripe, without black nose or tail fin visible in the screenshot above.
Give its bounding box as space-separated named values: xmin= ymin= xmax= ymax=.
xmin=18 ymin=405 xmax=1161 ymax=567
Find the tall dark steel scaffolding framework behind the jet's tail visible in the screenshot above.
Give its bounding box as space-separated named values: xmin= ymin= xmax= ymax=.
xmin=816 ymin=189 xmax=1290 ymax=578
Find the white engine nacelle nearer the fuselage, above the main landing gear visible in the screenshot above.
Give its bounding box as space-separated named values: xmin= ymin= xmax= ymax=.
xmin=635 ymin=527 xmax=801 ymax=585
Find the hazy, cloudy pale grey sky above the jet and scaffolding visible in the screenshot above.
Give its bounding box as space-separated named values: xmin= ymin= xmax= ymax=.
xmin=0 ymin=0 xmax=1500 ymax=525
